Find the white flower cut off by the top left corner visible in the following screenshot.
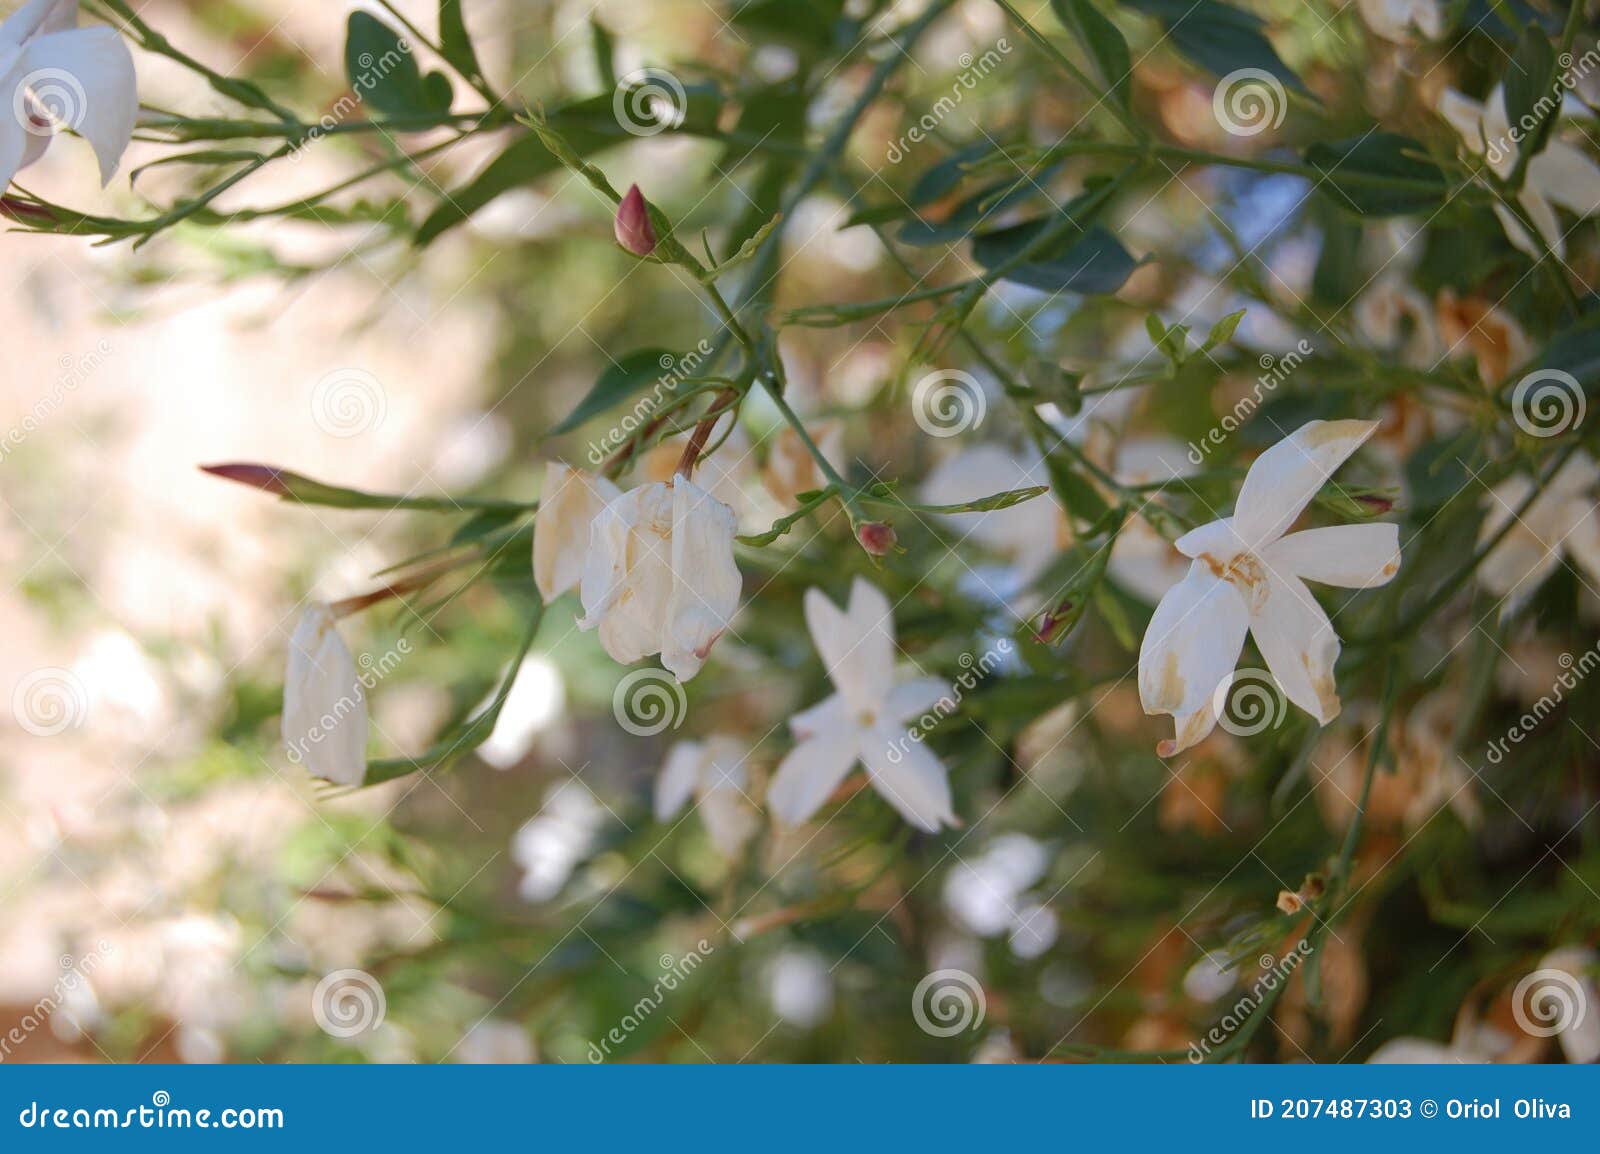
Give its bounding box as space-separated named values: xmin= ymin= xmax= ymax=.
xmin=0 ymin=0 xmax=139 ymax=190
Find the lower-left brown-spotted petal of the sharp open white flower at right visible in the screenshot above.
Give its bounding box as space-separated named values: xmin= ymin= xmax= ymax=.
xmin=1139 ymin=562 xmax=1250 ymax=757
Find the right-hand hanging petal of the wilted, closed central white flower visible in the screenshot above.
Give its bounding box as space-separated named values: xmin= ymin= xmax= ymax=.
xmin=661 ymin=477 xmax=744 ymax=682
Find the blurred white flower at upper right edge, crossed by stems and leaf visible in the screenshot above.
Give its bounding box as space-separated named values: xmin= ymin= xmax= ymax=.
xmin=1438 ymin=85 xmax=1600 ymax=259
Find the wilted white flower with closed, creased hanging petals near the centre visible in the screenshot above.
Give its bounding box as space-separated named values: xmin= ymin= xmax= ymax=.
xmin=578 ymin=475 xmax=742 ymax=682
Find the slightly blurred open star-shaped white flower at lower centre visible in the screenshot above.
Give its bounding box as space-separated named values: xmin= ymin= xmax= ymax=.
xmin=766 ymin=578 xmax=957 ymax=832
